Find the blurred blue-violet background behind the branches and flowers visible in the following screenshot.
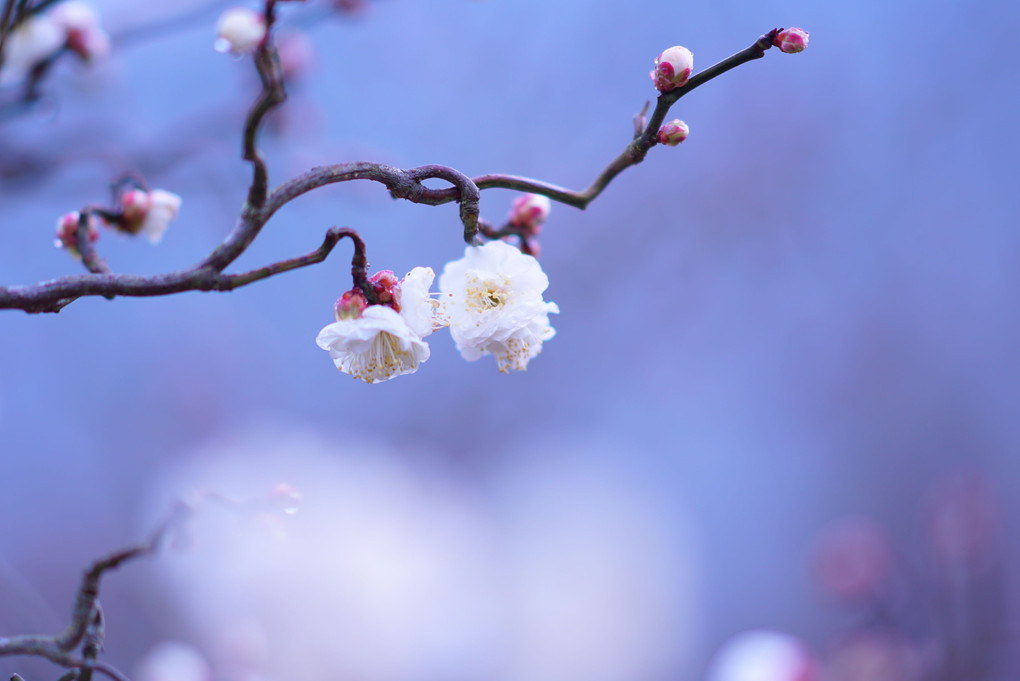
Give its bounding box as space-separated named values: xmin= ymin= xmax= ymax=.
xmin=0 ymin=0 xmax=1020 ymax=681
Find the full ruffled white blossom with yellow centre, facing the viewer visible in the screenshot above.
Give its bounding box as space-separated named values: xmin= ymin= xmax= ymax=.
xmin=440 ymin=241 xmax=560 ymax=373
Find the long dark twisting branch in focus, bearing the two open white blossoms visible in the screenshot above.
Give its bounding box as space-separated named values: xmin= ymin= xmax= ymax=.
xmin=0 ymin=26 xmax=795 ymax=313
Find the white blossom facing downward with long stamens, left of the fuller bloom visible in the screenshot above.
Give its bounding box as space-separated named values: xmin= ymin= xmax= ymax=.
xmin=315 ymin=267 xmax=442 ymax=383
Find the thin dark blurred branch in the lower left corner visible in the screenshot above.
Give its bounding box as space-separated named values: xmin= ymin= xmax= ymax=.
xmin=0 ymin=504 xmax=190 ymax=681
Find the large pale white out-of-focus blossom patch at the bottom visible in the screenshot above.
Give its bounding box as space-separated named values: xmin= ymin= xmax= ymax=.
xmin=147 ymin=425 xmax=691 ymax=681
